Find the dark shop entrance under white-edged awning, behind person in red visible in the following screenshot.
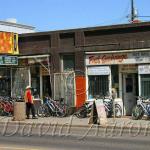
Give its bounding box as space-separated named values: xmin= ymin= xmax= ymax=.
xmin=18 ymin=54 xmax=51 ymax=99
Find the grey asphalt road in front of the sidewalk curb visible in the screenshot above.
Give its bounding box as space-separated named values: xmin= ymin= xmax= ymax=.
xmin=0 ymin=123 xmax=150 ymax=150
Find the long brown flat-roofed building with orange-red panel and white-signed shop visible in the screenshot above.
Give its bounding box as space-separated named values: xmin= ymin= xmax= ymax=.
xmin=19 ymin=22 xmax=150 ymax=115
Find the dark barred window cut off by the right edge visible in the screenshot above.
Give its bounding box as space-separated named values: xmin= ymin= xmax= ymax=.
xmin=141 ymin=74 xmax=150 ymax=98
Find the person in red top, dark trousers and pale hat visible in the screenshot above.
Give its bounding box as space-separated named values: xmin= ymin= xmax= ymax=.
xmin=24 ymin=86 xmax=37 ymax=119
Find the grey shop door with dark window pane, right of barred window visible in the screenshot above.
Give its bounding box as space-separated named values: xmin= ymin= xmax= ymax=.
xmin=123 ymin=74 xmax=137 ymax=115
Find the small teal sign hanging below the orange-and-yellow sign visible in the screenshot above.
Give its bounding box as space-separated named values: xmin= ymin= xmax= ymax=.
xmin=0 ymin=56 xmax=18 ymax=65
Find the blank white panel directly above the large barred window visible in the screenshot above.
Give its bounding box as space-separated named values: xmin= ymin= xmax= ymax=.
xmin=88 ymin=66 xmax=110 ymax=75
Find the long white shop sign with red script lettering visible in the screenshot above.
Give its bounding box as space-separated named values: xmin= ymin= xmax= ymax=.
xmin=86 ymin=52 xmax=150 ymax=65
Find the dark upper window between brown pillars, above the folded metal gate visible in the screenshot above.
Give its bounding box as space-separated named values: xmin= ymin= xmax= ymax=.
xmin=63 ymin=55 xmax=75 ymax=71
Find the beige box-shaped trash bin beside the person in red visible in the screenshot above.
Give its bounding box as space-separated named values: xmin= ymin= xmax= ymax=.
xmin=13 ymin=102 xmax=26 ymax=121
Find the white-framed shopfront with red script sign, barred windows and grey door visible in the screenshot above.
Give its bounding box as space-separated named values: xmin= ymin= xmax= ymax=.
xmin=86 ymin=49 xmax=150 ymax=115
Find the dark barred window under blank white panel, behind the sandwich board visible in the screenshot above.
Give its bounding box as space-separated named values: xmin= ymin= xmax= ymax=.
xmin=89 ymin=75 xmax=109 ymax=97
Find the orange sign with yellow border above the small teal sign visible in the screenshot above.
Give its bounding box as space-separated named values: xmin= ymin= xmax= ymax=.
xmin=0 ymin=32 xmax=19 ymax=54
